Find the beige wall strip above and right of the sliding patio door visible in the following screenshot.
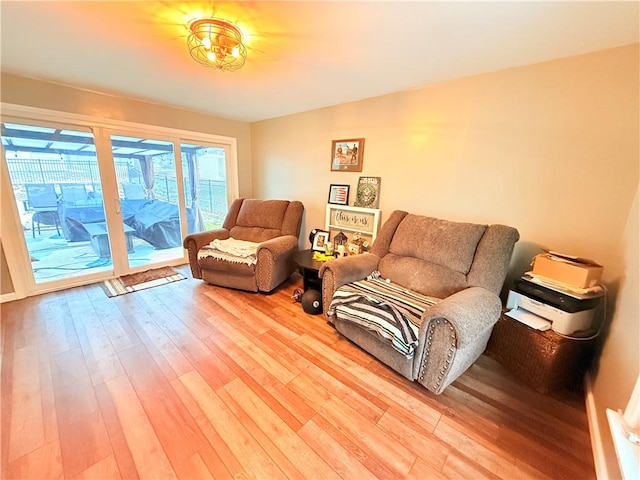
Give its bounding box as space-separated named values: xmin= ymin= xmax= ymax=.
xmin=0 ymin=73 xmax=252 ymax=294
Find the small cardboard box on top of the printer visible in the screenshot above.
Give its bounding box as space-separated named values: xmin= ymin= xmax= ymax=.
xmin=532 ymin=252 xmax=603 ymax=288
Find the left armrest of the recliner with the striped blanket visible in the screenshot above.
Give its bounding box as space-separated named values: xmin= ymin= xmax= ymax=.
xmin=318 ymin=253 xmax=380 ymax=314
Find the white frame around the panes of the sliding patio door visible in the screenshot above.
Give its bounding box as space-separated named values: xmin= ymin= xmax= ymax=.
xmin=0 ymin=102 xmax=239 ymax=299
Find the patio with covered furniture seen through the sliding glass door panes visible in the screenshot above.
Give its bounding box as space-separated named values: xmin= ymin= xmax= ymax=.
xmin=2 ymin=123 xmax=227 ymax=283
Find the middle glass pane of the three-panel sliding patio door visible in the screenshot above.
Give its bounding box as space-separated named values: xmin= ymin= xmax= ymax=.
xmin=110 ymin=135 xmax=184 ymax=269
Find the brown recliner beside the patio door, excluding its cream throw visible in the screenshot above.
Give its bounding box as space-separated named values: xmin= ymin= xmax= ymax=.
xmin=183 ymin=198 xmax=304 ymax=292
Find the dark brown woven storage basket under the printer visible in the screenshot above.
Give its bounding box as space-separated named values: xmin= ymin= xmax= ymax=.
xmin=485 ymin=315 xmax=596 ymax=393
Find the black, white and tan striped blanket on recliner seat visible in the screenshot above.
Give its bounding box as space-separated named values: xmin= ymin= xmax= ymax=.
xmin=327 ymin=275 xmax=438 ymax=357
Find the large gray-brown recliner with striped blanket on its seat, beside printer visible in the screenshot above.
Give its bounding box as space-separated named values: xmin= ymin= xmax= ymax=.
xmin=319 ymin=211 xmax=519 ymax=394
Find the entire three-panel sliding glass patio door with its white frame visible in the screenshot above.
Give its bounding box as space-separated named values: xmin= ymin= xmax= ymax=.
xmin=1 ymin=109 xmax=238 ymax=293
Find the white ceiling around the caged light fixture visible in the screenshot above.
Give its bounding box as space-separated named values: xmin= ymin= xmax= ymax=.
xmin=0 ymin=0 xmax=639 ymax=121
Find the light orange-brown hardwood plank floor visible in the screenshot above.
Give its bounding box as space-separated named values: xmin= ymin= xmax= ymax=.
xmin=1 ymin=268 xmax=595 ymax=479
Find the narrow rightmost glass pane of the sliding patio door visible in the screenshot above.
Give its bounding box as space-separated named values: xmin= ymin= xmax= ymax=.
xmin=180 ymin=143 xmax=228 ymax=233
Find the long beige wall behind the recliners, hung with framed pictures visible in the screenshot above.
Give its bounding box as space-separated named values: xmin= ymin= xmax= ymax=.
xmin=251 ymin=44 xmax=640 ymax=476
